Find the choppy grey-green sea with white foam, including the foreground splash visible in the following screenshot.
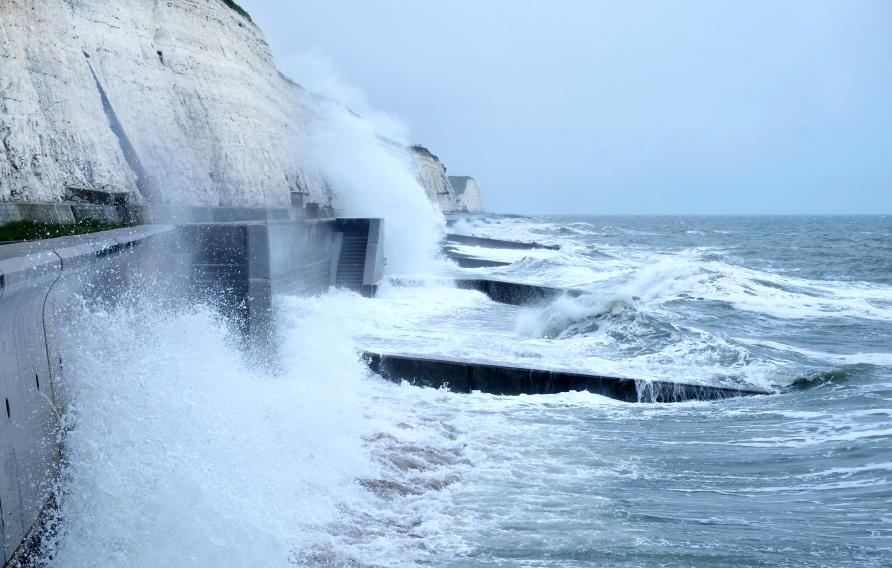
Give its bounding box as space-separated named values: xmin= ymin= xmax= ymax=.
xmin=47 ymin=216 xmax=892 ymax=567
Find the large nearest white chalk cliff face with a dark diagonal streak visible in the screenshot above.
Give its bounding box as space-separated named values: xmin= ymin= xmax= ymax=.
xmin=0 ymin=0 xmax=329 ymax=206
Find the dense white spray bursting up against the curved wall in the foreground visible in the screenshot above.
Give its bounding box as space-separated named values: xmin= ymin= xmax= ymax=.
xmin=43 ymin=300 xmax=374 ymax=566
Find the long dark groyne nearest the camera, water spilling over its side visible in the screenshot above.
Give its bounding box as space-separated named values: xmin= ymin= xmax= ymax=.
xmin=362 ymin=352 xmax=771 ymax=403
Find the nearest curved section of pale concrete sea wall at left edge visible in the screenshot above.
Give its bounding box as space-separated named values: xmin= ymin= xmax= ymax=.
xmin=0 ymin=226 xmax=173 ymax=561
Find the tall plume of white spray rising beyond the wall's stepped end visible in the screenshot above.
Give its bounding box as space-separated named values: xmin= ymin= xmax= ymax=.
xmin=285 ymin=52 xmax=445 ymax=274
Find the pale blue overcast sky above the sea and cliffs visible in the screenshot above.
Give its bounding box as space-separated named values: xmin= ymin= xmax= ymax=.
xmin=240 ymin=0 xmax=892 ymax=215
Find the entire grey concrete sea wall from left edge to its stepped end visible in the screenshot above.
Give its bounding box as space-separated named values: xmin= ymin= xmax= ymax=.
xmin=0 ymin=215 xmax=383 ymax=566
